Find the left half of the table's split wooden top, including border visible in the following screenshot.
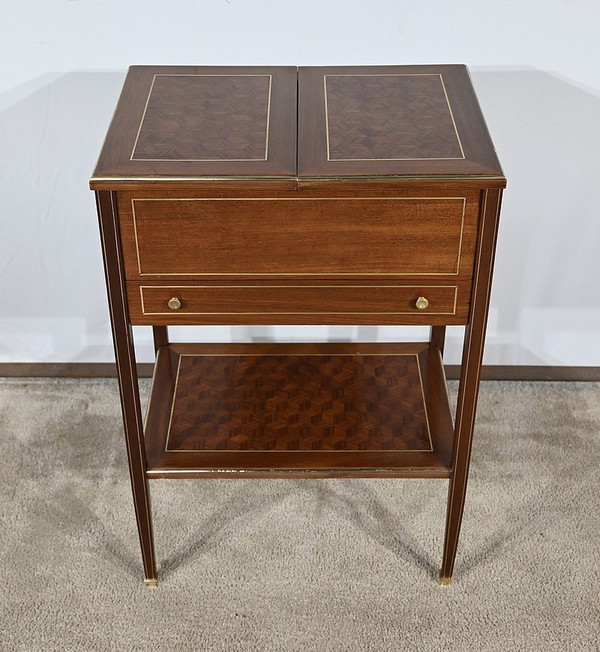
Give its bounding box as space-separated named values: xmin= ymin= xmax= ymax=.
xmin=90 ymin=66 xmax=297 ymax=188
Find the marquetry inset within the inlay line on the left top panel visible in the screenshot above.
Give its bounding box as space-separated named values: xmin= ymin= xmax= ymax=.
xmin=131 ymin=75 xmax=271 ymax=161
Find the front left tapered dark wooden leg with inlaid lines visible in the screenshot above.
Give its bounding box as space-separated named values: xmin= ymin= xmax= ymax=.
xmin=96 ymin=191 xmax=158 ymax=586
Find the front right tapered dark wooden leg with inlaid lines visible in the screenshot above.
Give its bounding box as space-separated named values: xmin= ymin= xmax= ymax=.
xmin=440 ymin=190 xmax=502 ymax=585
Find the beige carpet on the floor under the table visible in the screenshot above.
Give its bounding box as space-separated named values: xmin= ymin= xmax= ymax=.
xmin=0 ymin=380 xmax=600 ymax=652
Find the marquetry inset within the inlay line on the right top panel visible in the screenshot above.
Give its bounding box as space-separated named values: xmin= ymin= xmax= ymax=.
xmin=325 ymin=75 xmax=463 ymax=160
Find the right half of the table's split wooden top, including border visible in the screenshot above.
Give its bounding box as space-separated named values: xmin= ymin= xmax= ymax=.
xmin=298 ymin=65 xmax=503 ymax=177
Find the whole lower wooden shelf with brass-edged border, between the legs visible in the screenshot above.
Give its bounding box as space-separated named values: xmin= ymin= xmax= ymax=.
xmin=145 ymin=343 xmax=453 ymax=477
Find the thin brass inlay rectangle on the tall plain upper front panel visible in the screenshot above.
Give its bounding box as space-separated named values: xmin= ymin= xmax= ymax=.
xmin=131 ymin=197 xmax=467 ymax=276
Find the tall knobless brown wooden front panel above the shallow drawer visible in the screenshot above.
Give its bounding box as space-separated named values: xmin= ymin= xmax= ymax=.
xmin=119 ymin=192 xmax=478 ymax=280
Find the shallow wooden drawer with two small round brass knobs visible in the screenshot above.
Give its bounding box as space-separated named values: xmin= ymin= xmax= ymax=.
xmin=128 ymin=282 xmax=469 ymax=325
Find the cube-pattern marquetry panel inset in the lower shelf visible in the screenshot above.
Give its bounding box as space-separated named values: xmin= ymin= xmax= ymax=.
xmin=166 ymin=355 xmax=431 ymax=451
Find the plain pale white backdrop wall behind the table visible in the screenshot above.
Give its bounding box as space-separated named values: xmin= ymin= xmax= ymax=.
xmin=0 ymin=0 xmax=600 ymax=366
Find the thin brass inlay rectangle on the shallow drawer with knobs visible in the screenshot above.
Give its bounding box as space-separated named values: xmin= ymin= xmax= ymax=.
xmin=139 ymin=284 xmax=458 ymax=316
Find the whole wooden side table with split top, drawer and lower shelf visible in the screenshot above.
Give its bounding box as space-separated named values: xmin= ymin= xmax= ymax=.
xmin=90 ymin=65 xmax=505 ymax=585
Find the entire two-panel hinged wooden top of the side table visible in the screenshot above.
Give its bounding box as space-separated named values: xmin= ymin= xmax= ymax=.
xmin=91 ymin=65 xmax=503 ymax=188
